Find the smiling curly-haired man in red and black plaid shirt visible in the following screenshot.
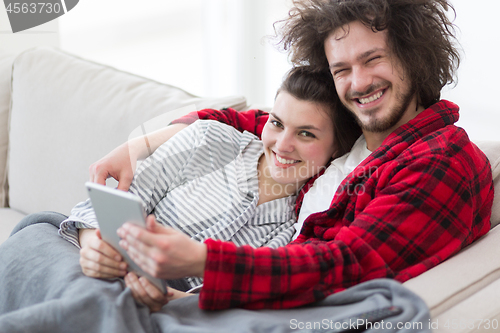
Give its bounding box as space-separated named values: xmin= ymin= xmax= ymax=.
xmin=89 ymin=0 xmax=493 ymax=309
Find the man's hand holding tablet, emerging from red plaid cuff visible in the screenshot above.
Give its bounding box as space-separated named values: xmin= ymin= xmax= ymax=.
xmin=118 ymin=215 xmax=207 ymax=279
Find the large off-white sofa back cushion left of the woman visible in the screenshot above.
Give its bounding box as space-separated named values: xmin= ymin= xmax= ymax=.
xmin=8 ymin=48 xmax=246 ymax=214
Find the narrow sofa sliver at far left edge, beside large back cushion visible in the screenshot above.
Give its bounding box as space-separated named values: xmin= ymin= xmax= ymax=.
xmin=0 ymin=50 xmax=14 ymax=207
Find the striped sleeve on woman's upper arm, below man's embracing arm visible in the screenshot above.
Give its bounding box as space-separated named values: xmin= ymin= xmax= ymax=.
xmin=130 ymin=120 xmax=241 ymax=214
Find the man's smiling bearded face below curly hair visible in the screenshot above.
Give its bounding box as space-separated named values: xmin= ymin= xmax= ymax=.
xmin=325 ymin=21 xmax=416 ymax=135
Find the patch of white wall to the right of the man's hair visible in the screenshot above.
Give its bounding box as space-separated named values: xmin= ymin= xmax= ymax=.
xmin=443 ymin=0 xmax=500 ymax=140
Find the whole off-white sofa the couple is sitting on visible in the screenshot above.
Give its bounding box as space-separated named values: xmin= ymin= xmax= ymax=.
xmin=0 ymin=48 xmax=500 ymax=332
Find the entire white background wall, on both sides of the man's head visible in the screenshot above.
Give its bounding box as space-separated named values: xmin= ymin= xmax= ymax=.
xmin=0 ymin=0 xmax=500 ymax=140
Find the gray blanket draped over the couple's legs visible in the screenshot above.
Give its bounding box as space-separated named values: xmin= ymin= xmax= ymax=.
xmin=0 ymin=217 xmax=431 ymax=333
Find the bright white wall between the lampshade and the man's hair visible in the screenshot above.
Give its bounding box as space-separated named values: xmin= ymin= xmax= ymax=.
xmin=59 ymin=0 xmax=290 ymax=106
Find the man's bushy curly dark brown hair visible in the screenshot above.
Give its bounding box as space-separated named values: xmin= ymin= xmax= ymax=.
xmin=276 ymin=0 xmax=460 ymax=107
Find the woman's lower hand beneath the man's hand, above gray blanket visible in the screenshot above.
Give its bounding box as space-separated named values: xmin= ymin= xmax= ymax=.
xmin=125 ymin=272 xmax=192 ymax=312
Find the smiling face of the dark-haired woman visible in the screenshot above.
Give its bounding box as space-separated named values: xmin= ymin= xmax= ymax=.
xmin=262 ymin=91 xmax=336 ymax=186
